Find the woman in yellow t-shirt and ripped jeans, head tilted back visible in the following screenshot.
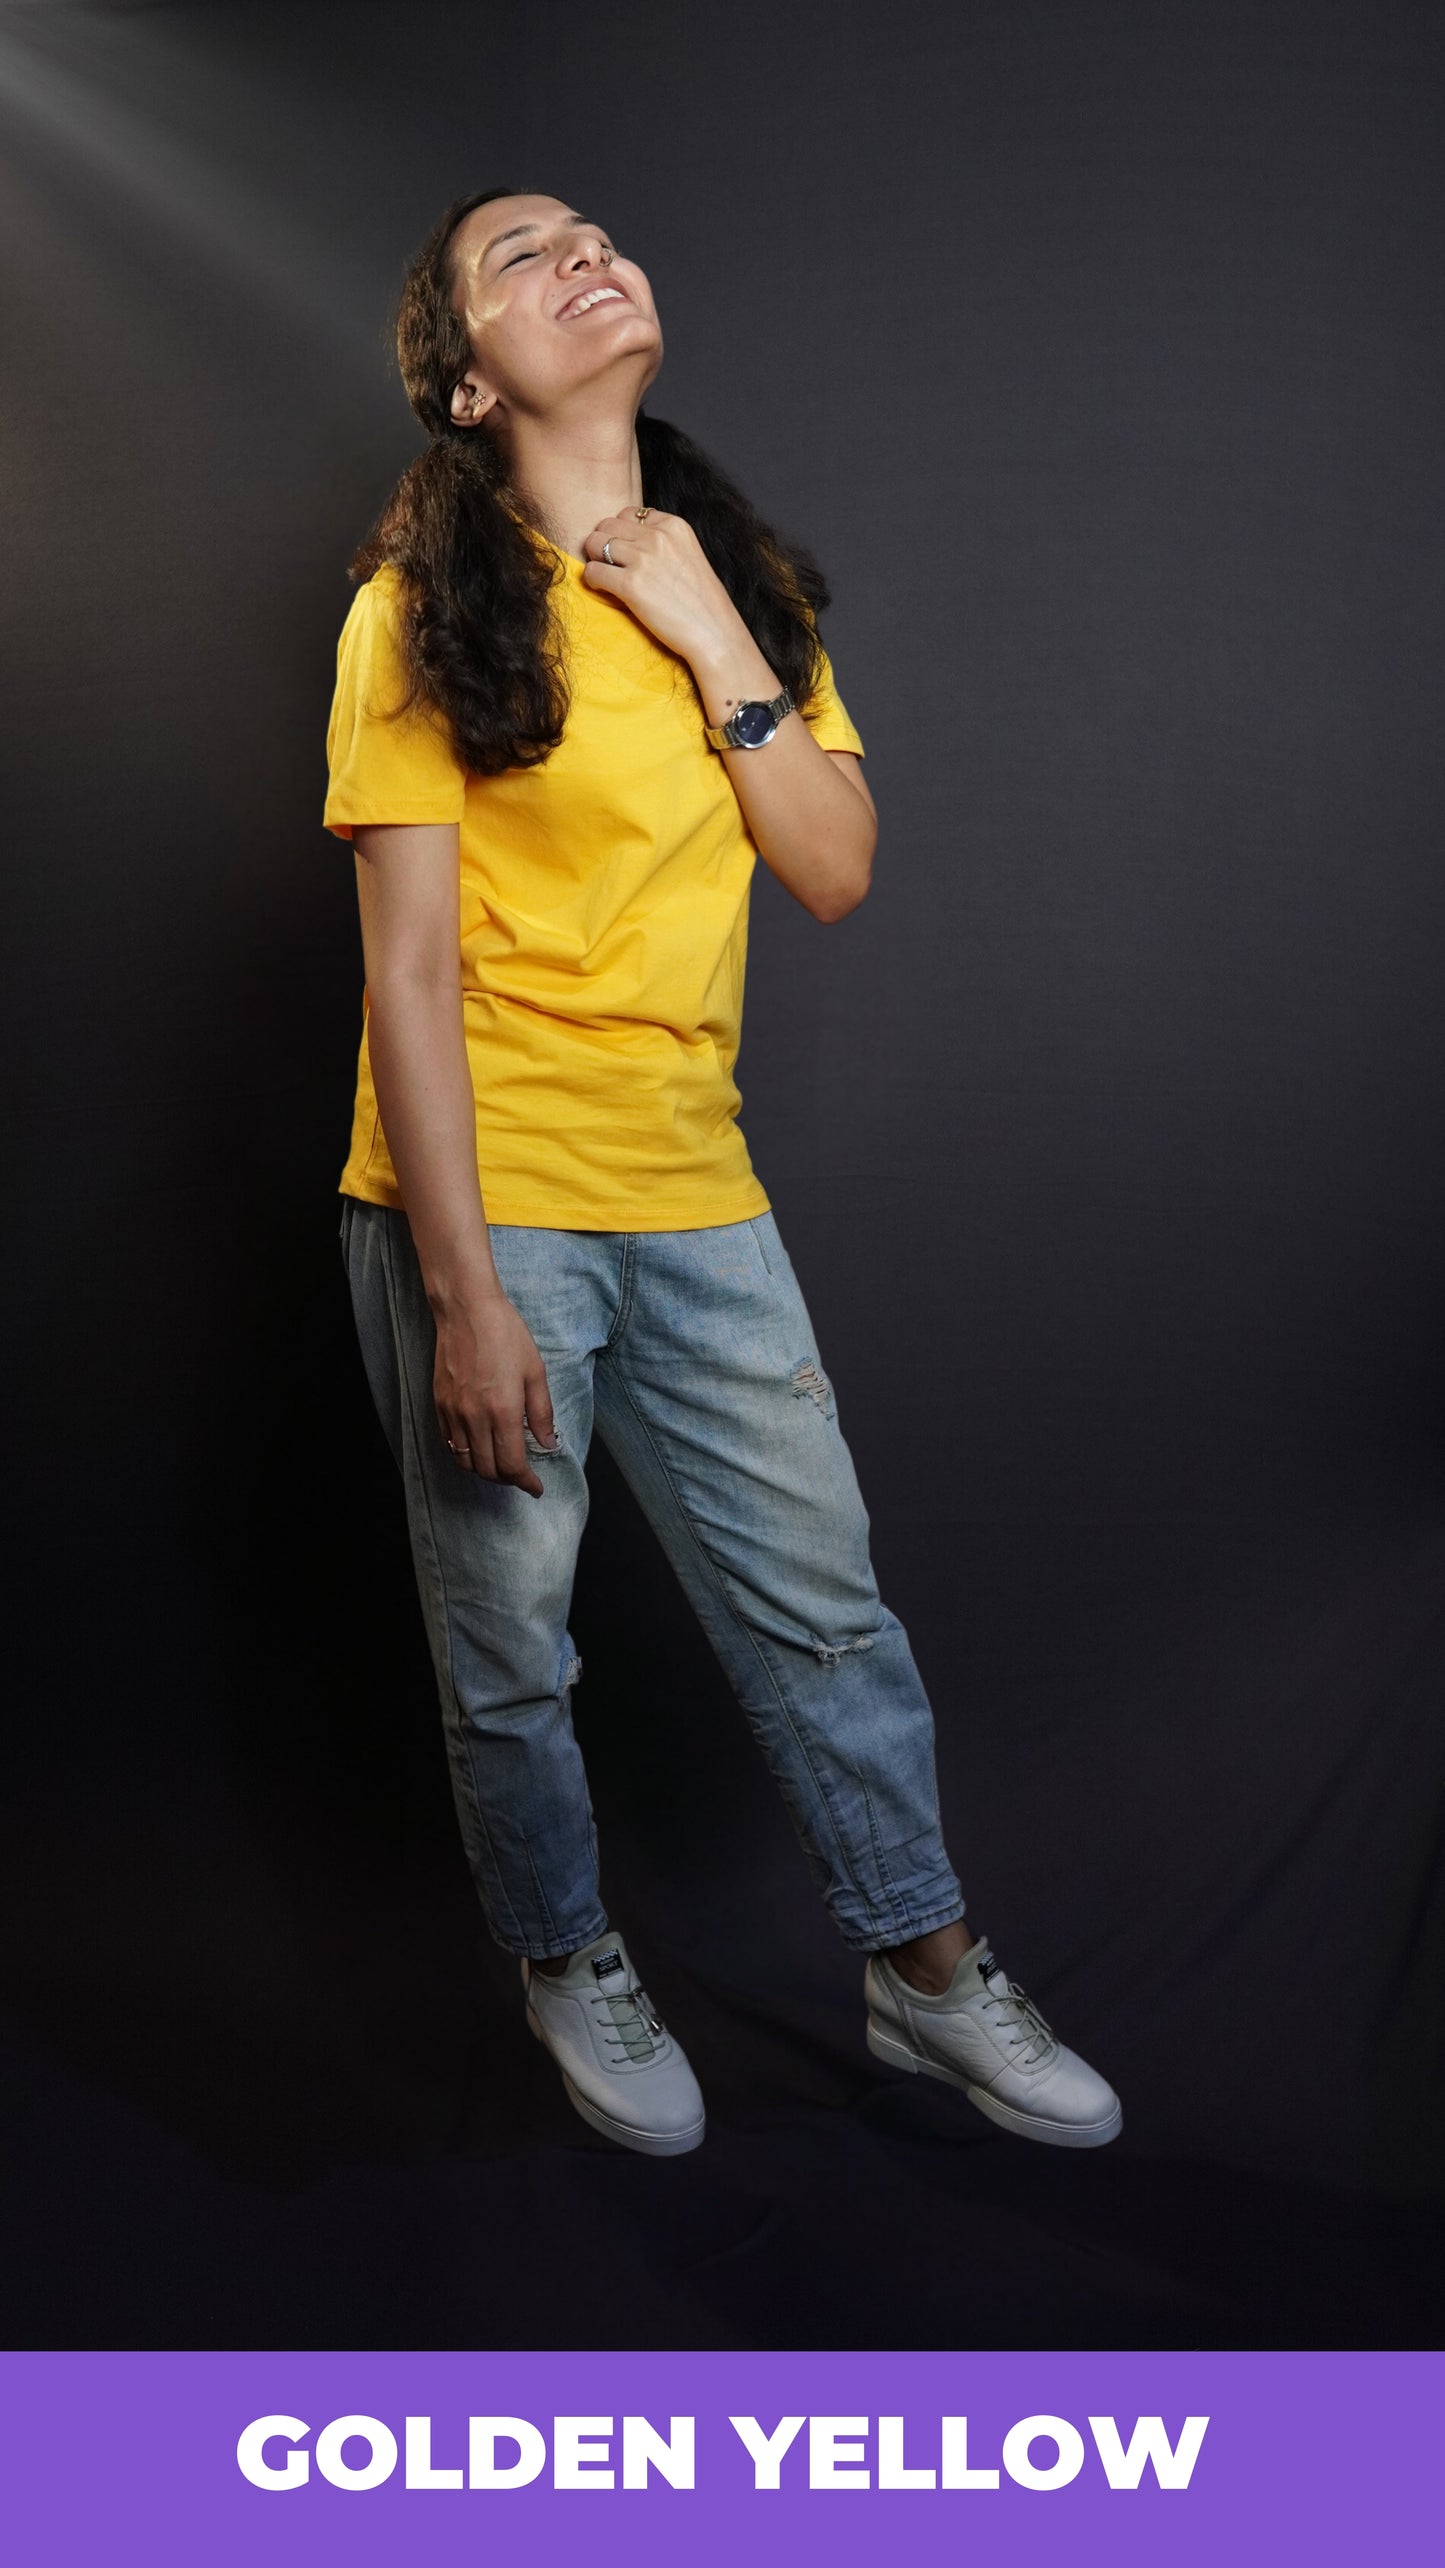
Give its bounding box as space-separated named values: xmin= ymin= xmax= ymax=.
xmin=326 ymin=190 xmax=1119 ymax=2155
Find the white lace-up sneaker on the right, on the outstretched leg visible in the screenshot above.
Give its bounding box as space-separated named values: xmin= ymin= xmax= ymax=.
xmin=862 ymin=1936 xmax=1124 ymax=2149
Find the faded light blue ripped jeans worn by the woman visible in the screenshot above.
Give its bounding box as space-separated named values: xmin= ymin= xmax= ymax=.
xmin=341 ymin=1197 xmax=962 ymax=1959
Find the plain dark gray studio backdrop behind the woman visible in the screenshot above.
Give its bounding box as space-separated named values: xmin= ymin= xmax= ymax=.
xmin=0 ymin=0 xmax=1445 ymax=2345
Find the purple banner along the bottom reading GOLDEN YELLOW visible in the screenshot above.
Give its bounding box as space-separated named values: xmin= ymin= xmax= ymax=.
xmin=0 ymin=2352 xmax=1445 ymax=2568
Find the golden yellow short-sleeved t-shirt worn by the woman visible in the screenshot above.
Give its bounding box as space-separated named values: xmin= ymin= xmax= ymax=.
xmin=323 ymin=555 xmax=862 ymax=1230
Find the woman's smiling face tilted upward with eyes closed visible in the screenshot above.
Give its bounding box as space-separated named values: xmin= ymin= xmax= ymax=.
xmin=452 ymin=195 xmax=662 ymax=421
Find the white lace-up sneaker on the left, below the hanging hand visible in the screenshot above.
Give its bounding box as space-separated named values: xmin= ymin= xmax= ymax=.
xmin=521 ymin=1926 xmax=706 ymax=2157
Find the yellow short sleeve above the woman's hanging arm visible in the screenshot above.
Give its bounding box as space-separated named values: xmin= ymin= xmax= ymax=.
xmin=321 ymin=568 xmax=467 ymax=837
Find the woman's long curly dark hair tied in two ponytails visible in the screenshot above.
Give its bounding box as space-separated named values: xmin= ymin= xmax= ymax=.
xmin=349 ymin=187 xmax=829 ymax=776
